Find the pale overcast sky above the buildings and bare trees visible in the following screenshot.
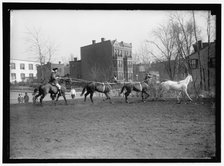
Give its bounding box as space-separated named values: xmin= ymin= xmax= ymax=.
xmin=10 ymin=10 xmax=214 ymax=63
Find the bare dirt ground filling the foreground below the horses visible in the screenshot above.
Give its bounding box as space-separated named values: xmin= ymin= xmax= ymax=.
xmin=10 ymin=98 xmax=216 ymax=159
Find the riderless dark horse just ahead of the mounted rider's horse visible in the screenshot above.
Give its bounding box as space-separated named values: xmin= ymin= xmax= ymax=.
xmin=80 ymin=82 xmax=112 ymax=103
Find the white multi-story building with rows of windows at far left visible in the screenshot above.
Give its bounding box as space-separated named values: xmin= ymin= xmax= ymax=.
xmin=10 ymin=59 xmax=40 ymax=83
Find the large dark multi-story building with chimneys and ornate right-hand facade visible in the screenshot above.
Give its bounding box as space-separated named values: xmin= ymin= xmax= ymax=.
xmin=81 ymin=38 xmax=133 ymax=81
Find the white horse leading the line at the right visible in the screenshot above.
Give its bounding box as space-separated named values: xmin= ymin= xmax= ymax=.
xmin=161 ymin=74 xmax=193 ymax=102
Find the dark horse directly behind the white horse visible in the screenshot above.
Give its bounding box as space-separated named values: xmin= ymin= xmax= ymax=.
xmin=120 ymin=75 xmax=151 ymax=103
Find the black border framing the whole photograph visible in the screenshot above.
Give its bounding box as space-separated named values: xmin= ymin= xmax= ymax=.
xmin=2 ymin=3 xmax=221 ymax=163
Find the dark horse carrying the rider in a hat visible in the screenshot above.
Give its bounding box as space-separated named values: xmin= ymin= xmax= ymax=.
xmin=34 ymin=79 xmax=67 ymax=104
